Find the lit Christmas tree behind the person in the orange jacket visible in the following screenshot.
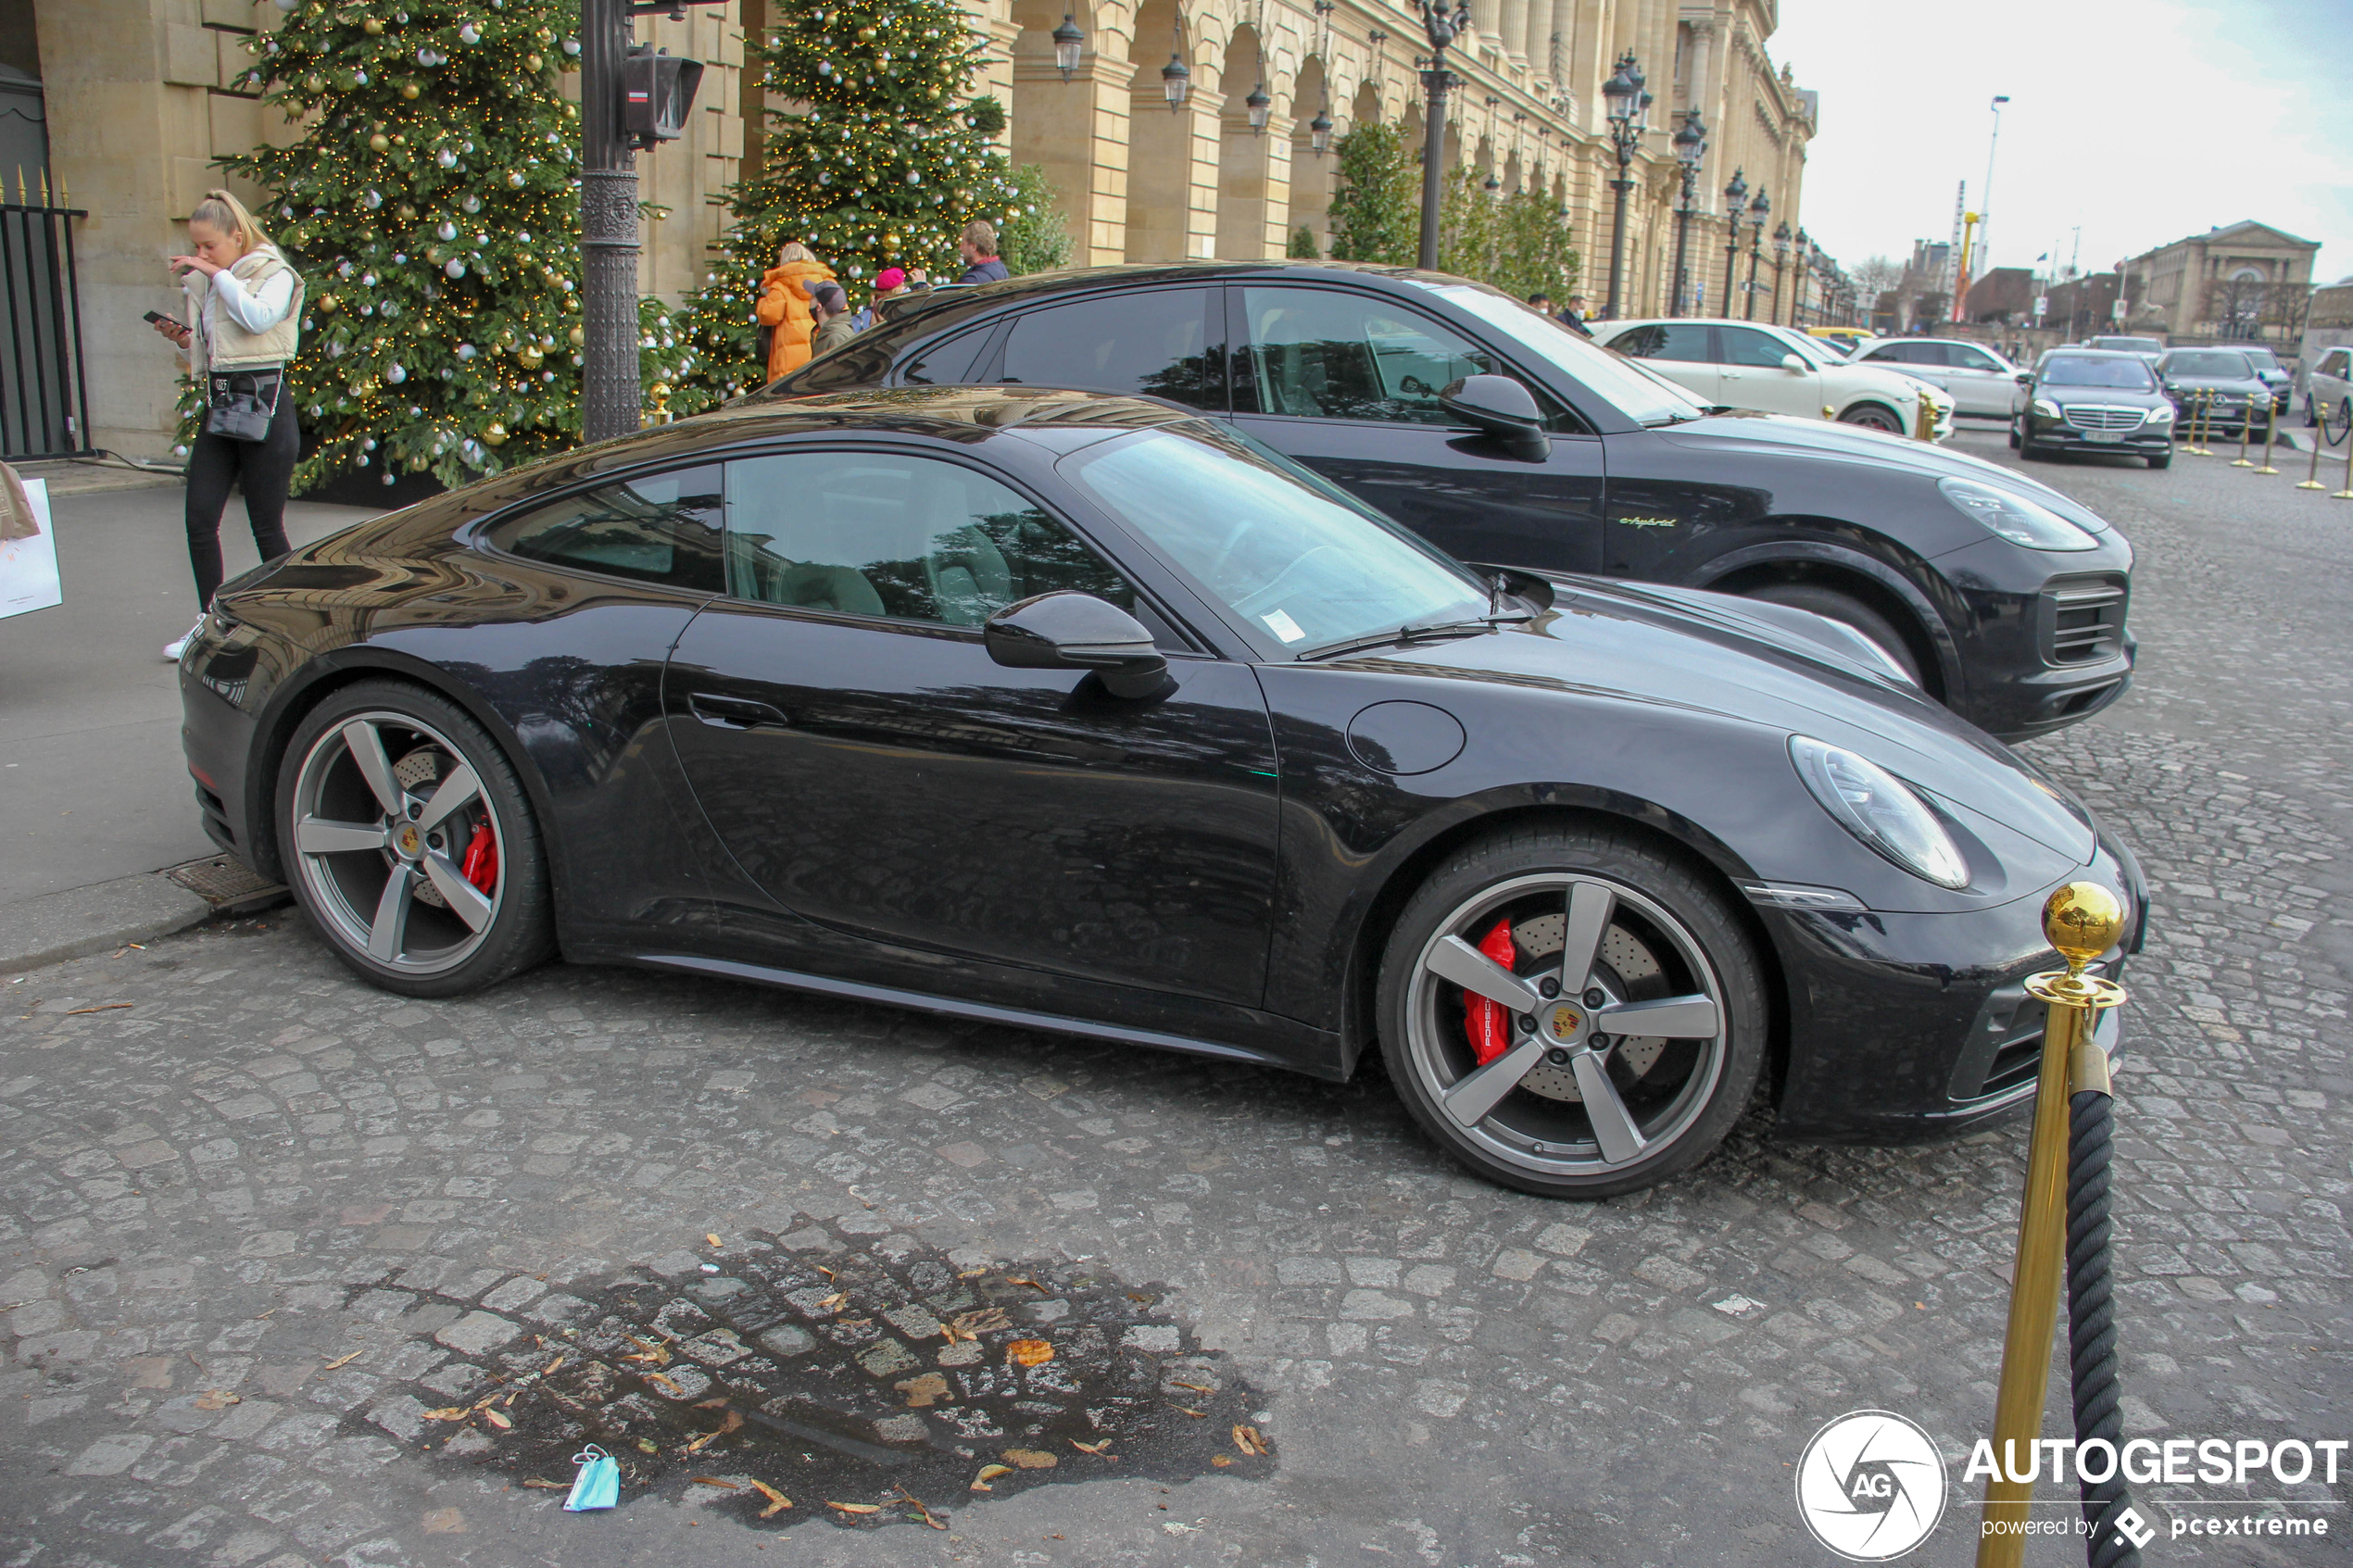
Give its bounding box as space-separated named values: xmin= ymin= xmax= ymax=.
xmin=675 ymin=0 xmax=1019 ymax=411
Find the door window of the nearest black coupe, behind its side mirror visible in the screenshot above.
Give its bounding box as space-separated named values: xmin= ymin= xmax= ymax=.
xmin=727 ymin=451 xmax=1137 ymax=628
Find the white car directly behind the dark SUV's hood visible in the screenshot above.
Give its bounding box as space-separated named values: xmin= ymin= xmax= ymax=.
xmin=1593 ymin=318 xmax=1953 ymax=442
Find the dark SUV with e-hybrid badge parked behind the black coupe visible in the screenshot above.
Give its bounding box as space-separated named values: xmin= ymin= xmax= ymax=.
xmin=760 ymin=261 xmax=2134 ymax=741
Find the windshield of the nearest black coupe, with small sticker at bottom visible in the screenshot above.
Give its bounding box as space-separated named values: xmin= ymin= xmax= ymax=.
xmin=1056 ymin=428 xmax=1487 ymax=654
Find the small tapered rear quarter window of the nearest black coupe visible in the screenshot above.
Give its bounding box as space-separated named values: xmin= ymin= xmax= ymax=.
xmin=487 ymin=463 xmax=724 ymax=593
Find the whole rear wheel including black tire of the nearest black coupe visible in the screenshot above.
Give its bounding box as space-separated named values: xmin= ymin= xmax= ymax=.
xmin=273 ymin=680 xmax=555 ymax=997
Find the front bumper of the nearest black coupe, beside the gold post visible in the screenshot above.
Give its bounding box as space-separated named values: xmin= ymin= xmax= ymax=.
xmin=1757 ymin=837 xmax=2148 ymax=1143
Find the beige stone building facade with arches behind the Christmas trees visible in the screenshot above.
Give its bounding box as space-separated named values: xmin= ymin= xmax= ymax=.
xmin=0 ymin=0 xmax=1818 ymax=456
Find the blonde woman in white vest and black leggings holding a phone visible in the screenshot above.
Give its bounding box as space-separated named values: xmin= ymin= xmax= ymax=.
xmin=156 ymin=191 xmax=304 ymax=663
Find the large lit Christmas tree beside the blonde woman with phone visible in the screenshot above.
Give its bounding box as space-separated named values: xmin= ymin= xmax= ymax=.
xmin=221 ymin=0 xmax=692 ymax=489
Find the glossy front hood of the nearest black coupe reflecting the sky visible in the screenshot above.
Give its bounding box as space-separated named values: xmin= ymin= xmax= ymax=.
xmin=1355 ymin=578 xmax=2095 ymax=863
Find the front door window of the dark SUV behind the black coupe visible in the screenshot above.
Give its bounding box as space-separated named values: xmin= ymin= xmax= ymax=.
xmin=1242 ymin=289 xmax=1499 ymax=425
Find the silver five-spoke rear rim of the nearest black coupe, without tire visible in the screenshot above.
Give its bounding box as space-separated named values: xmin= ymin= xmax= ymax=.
xmin=292 ymin=710 xmax=510 ymax=975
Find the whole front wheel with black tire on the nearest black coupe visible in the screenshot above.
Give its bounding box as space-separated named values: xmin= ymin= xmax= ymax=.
xmin=1377 ymin=825 xmax=1768 ymax=1198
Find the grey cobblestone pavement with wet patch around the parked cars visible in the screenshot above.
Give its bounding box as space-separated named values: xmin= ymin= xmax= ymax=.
xmin=0 ymin=437 xmax=2353 ymax=1568
